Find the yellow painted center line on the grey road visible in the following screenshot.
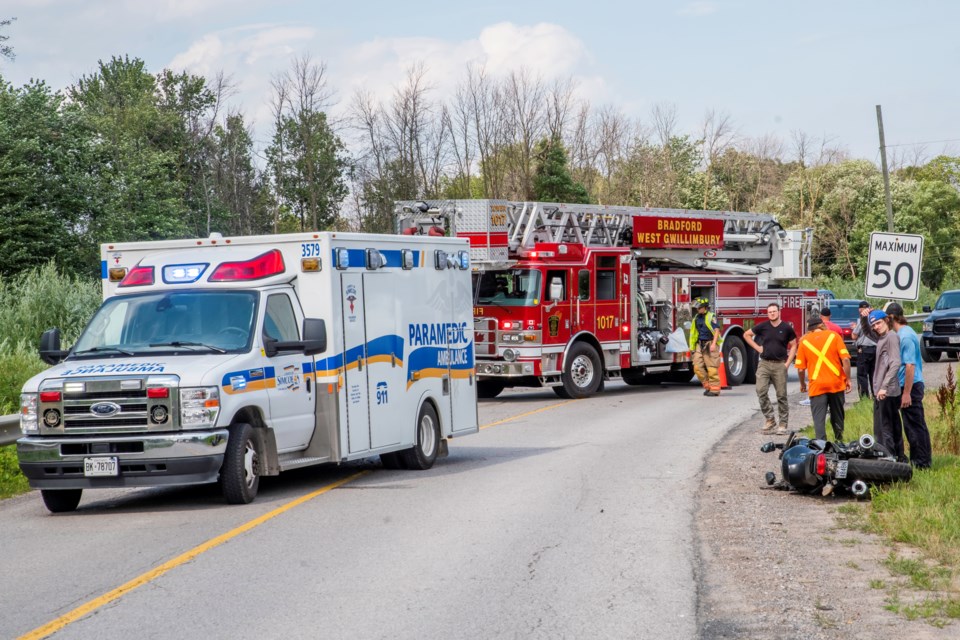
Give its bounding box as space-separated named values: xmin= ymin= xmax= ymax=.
xmin=18 ymin=400 xmax=576 ymax=640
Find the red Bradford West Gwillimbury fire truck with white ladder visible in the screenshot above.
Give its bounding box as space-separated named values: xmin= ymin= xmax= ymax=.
xmin=395 ymin=200 xmax=819 ymax=398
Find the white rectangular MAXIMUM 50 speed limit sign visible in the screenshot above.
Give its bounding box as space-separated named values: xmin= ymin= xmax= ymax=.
xmin=867 ymin=232 xmax=923 ymax=300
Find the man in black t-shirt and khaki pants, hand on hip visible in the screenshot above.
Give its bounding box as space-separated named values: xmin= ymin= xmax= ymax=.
xmin=743 ymin=302 xmax=797 ymax=435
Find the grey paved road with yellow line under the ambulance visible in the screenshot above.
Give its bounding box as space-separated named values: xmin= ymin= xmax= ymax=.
xmin=0 ymin=383 xmax=756 ymax=638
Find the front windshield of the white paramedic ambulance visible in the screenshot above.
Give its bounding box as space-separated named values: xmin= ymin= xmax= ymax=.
xmin=73 ymin=291 xmax=257 ymax=356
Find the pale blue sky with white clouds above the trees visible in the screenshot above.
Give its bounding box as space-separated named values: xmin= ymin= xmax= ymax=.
xmin=0 ymin=0 xmax=960 ymax=164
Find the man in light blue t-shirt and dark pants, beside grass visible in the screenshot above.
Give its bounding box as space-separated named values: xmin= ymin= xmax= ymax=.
xmin=887 ymin=302 xmax=933 ymax=469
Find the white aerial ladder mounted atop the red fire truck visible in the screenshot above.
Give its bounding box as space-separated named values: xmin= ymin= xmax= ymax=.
xmin=395 ymin=200 xmax=813 ymax=282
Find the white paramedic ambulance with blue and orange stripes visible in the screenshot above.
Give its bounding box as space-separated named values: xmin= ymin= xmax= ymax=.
xmin=17 ymin=232 xmax=477 ymax=512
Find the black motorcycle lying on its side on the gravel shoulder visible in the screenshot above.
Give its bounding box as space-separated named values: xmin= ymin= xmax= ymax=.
xmin=760 ymin=431 xmax=913 ymax=498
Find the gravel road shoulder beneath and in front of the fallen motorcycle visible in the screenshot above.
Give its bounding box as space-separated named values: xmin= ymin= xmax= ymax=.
xmin=696 ymin=362 xmax=960 ymax=640
